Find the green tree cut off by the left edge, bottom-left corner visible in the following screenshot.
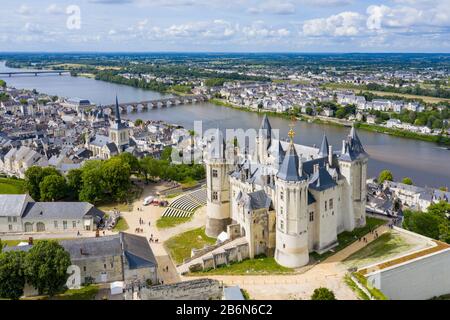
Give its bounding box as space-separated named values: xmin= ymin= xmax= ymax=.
xmin=0 ymin=251 xmax=25 ymax=300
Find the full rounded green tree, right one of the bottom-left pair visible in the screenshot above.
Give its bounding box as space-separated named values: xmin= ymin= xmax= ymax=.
xmin=24 ymin=240 xmax=71 ymax=296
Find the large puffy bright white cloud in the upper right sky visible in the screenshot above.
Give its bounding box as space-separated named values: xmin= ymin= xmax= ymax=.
xmin=303 ymin=11 xmax=364 ymax=37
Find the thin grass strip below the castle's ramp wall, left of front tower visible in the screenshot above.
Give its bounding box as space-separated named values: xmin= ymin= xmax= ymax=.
xmin=192 ymin=256 xmax=294 ymax=275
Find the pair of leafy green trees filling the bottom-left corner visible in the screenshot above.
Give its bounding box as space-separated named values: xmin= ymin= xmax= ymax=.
xmin=0 ymin=241 xmax=71 ymax=300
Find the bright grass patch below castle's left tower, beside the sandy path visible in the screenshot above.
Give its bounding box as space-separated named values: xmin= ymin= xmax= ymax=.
xmin=164 ymin=227 xmax=216 ymax=263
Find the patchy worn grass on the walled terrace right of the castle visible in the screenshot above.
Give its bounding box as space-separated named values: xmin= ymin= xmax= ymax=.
xmin=344 ymin=232 xmax=414 ymax=268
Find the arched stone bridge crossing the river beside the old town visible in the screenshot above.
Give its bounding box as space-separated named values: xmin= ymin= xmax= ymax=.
xmin=100 ymin=95 xmax=208 ymax=115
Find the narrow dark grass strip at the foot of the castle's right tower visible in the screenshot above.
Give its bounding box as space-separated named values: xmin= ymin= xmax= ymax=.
xmin=310 ymin=217 xmax=386 ymax=261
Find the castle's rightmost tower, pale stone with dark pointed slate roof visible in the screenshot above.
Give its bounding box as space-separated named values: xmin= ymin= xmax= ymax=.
xmin=339 ymin=127 xmax=369 ymax=231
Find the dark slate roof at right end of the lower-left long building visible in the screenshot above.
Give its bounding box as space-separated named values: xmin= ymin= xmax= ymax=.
xmin=120 ymin=233 xmax=158 ymax=270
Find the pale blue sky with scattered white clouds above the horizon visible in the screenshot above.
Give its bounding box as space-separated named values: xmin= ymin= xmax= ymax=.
xmin=0 ymin=0 xmax=450 ymax=53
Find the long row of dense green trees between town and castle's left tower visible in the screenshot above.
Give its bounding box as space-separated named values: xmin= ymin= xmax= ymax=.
xmin=25 ymin=148 xmax=205 ymax=204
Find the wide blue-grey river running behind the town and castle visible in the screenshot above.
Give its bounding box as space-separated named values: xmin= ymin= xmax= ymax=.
xmin=0 ymin=63 xmax=450 ymax=187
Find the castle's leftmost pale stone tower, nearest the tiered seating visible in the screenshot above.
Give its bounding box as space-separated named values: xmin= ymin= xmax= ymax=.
xmin=205 ymin=130 xmax=232 ymax=238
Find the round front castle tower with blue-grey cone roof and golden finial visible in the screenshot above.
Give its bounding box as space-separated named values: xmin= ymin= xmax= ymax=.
xmin=275 ymin=129 xmax=309 ymax=268
